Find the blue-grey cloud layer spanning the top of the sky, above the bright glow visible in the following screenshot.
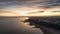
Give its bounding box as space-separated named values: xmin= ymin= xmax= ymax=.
xmin=0 ymin=0 xmax=60 ymax=9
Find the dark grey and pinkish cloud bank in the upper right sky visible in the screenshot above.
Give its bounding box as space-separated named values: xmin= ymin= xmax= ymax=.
xmin=23 ymin=0 xmax=60 ymax=8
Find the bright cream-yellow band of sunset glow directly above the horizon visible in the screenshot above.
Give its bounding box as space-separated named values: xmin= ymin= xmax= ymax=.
xmin=0 ymin=7 xmax=60 ymax=16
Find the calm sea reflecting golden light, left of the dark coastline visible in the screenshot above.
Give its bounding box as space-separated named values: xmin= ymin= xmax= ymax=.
xmin=0 ymin=17 xmax=43 ymax=34
